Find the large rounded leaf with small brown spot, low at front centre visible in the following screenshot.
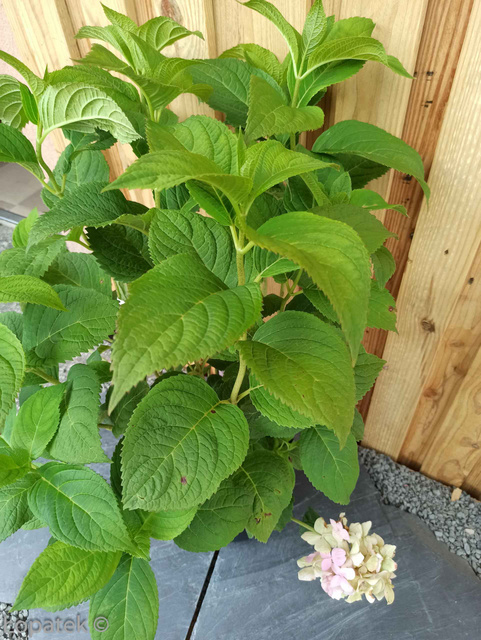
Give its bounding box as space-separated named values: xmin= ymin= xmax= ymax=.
xmin=122 ymin=375 xmax=249 ymax=511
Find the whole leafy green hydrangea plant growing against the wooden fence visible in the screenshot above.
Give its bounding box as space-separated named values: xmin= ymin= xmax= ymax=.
xmin=0 ymin=0 xmax=428 ymax=640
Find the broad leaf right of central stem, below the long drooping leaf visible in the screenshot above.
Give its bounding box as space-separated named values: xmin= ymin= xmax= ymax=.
xmin=239 ymin=311 xmax=354 ymax=441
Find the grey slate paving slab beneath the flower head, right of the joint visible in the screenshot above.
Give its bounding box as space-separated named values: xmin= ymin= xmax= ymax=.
xmin=193 ymin=470 xmax=481 ymax=640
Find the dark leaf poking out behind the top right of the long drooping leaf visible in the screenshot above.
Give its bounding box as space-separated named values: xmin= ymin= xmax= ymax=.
xmin=311 ymin=204 xmax=396 ymax=254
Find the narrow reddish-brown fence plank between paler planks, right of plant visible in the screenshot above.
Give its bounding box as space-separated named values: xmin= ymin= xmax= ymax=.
xmin=362 ymin=0 xmax=473 ymax=415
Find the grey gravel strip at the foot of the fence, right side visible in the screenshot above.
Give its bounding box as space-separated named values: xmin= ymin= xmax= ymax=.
xmin=359 ymin=447 xmax=481 ymax=578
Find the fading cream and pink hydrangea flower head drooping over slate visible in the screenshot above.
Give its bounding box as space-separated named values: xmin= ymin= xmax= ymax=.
xmin=297 ymin=513 xmax=397 ymax=604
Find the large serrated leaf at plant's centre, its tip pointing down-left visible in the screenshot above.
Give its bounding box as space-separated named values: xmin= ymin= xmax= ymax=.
xmin=110 ymin=254 xmax=262 ymax=408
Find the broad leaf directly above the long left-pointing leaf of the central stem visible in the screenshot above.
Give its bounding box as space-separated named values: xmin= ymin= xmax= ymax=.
xmin=146 ymin=116 xmax=238 ymax=173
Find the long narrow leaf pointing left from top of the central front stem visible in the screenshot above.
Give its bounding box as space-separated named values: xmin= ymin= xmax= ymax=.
xmin=105 ymin=150 xmax=251 ymax=201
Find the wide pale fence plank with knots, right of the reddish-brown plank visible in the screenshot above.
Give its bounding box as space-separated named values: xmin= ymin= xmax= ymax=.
xmin=364 ymin=0 xmax=481 ymax=464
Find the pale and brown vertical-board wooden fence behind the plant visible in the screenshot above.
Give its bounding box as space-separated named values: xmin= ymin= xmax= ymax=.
xmin=3 ymin=0 xmax=481 ymax=495
